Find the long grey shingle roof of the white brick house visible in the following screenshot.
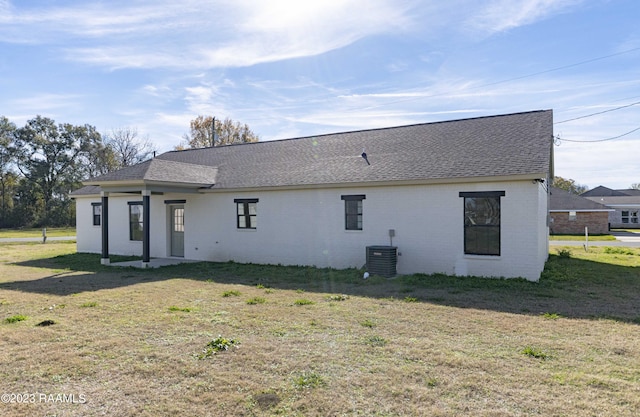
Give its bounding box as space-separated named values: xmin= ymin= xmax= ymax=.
xmin=79 ymin=110 xmax=553 ymax=189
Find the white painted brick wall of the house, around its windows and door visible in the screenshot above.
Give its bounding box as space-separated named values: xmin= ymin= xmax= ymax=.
xmin=78 ymin=181 xmax=547 ymax=280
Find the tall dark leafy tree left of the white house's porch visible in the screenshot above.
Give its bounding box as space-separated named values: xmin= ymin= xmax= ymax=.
xmin=12 ymin=116 xmax=100 ymax=226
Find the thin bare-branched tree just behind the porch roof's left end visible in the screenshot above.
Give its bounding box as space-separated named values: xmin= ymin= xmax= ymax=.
xmin=105 ymin=127 xmax=157 ymax=169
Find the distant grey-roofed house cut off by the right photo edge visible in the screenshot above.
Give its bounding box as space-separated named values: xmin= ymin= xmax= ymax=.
xmin=580 ymin=185 xmax=640 ymax=229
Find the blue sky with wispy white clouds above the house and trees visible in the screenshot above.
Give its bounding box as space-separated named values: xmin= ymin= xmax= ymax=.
xmin=0 ymin=0 xmax=640 ymax=188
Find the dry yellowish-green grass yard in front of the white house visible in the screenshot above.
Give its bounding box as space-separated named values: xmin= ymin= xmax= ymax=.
xmin=0 ymin=243 xmax=640 ymax=417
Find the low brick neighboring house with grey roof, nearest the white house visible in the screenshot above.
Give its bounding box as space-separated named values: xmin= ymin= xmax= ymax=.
xmin=549 ymin=187 xmax=614 ymax=235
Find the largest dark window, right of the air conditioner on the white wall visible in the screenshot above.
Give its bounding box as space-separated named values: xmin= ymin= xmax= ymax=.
xmin=460 ymin=191 xmax=505 ymax=256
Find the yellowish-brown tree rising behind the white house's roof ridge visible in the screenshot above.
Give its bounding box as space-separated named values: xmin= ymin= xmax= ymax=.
xmin=176 ymin=116 xmax=260 ymax=150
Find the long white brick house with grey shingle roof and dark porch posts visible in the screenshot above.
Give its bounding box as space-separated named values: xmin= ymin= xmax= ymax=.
xmin=72 ymin=110 xmax=553 ymax=280
